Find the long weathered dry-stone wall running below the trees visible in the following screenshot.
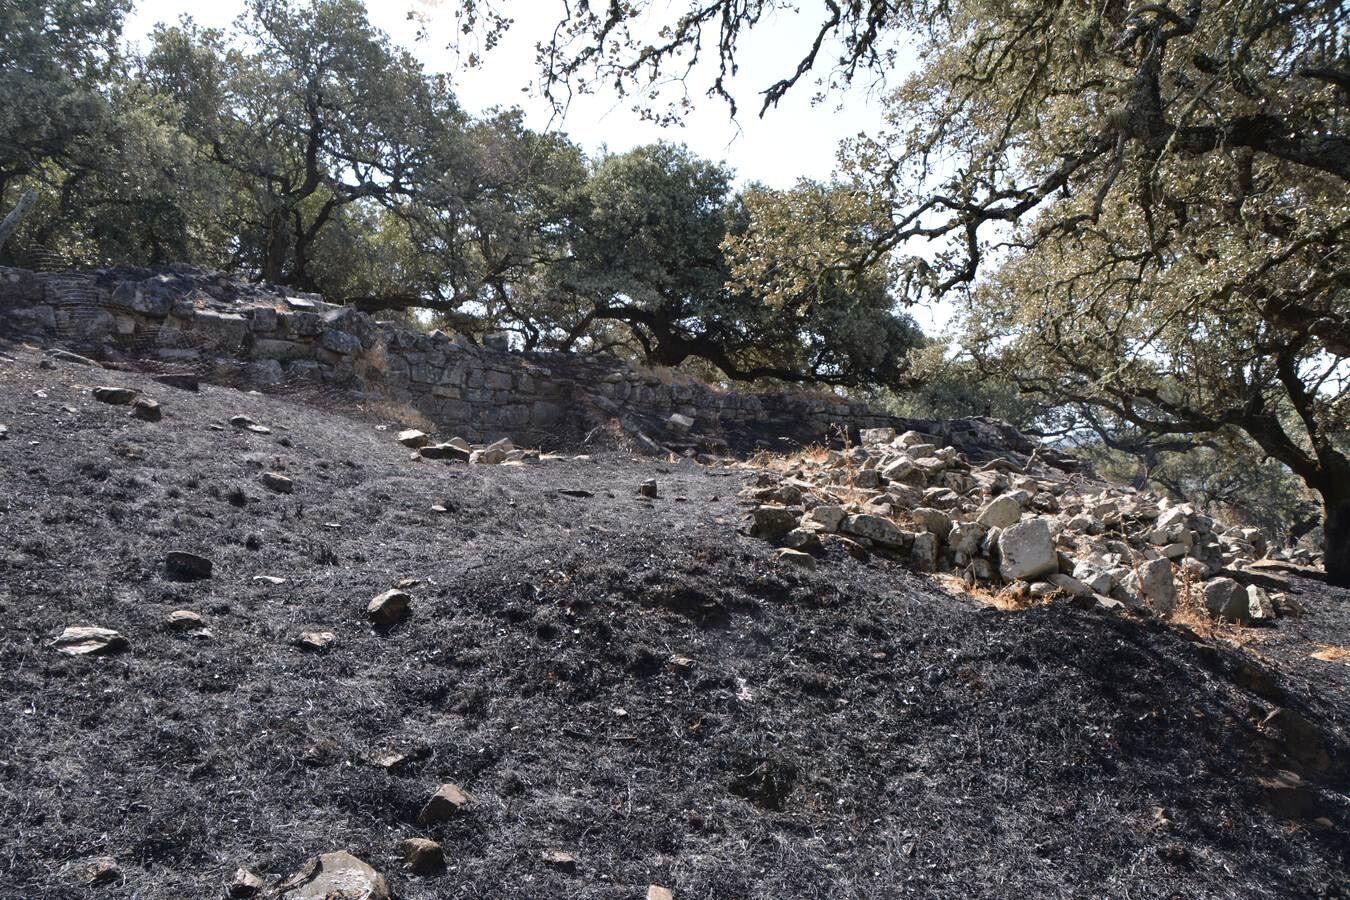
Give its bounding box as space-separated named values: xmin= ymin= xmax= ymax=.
xmin=0 ymin=261 xmax=1053 ymax=453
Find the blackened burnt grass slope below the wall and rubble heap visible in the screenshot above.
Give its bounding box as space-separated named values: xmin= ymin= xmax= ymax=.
xmin=0 ymin=348 xmax=1350 ymax=899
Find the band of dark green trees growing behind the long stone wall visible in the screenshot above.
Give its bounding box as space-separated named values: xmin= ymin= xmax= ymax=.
xmin=0 ymin=0 xmax=917 ymax=386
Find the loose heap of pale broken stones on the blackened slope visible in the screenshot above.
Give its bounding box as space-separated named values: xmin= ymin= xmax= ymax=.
xmin=741 ymin=428 xmax=1316 ymax=625
